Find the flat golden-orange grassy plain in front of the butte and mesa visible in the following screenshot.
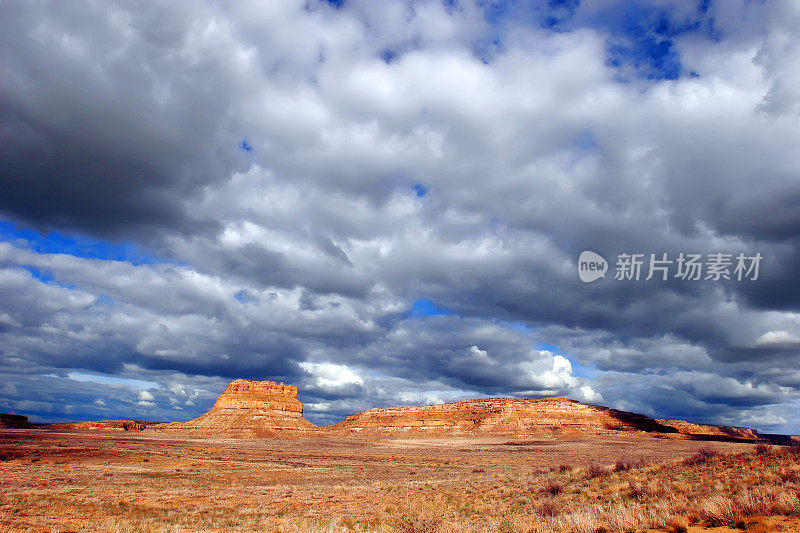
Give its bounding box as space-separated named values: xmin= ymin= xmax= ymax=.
xmin=0 ymin=430 xmax=800 ymax=533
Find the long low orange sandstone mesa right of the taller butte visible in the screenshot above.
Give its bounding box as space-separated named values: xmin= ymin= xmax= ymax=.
xmin=331 ymin=398 xmax=678 ymax=436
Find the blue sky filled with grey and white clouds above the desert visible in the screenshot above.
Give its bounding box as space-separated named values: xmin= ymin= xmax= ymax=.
xmin=0 ymin=0 xmax=800 ymax=433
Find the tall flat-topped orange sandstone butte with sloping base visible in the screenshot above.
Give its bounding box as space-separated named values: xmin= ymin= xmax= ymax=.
xmin=153 ymin=379 xmax=316 ymax=437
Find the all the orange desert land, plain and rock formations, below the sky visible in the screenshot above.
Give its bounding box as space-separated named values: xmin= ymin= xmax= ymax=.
xmin=0 ymin=380 xmax=800 ymax=533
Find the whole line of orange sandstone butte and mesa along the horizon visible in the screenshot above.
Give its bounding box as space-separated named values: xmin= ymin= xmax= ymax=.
xmin=7 ymin=379 xmax=800 ymax=445
